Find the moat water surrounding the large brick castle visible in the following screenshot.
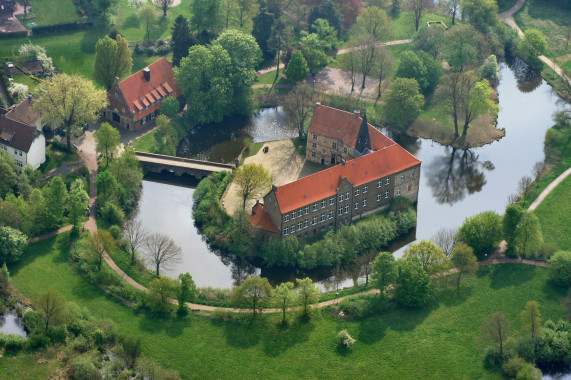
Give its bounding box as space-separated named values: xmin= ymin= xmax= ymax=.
xmin=134 ymin=64 xmax=559 ymax=289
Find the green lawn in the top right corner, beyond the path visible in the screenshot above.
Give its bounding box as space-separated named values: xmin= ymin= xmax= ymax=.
xmin=514 ymin=0 xmax=571 ymax=59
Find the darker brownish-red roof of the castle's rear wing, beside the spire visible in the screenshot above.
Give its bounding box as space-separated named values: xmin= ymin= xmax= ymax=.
xmin=308 ymin=105 xmax=395 ymax=150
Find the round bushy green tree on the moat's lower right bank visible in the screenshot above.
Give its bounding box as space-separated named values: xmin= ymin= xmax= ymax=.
xmin=459 ymin=211 xmax=502 ymax=259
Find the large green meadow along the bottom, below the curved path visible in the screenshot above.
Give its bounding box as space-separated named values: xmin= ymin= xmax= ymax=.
xmin=7 ymin=235 xmax=564 ymax=379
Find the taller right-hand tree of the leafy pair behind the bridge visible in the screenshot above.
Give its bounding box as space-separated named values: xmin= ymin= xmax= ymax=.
xmin=213 ymin=30 xmax=262 ymax=115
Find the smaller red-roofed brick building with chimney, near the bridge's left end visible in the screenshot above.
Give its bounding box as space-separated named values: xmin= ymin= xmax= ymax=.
xmin=103 ymin=58 xmax=182 ymax=130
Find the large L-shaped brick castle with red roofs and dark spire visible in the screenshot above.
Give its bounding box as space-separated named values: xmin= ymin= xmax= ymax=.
xmin=250 ymin=104 xmax=421 ymax=237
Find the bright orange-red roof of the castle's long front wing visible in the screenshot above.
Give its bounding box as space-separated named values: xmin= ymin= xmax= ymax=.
xmin=275 ymin=143 xmax=420 ymax=214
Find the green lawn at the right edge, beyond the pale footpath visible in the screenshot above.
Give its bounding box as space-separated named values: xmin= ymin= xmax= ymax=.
xmin=535 ymin=177 xmax=571 ymax=251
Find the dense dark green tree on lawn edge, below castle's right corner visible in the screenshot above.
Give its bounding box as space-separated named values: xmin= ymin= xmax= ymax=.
xmin=395 ymin=258 xmax=430 ymax=307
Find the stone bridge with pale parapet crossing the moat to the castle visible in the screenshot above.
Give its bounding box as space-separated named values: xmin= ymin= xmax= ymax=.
xmin=135 ymin=152 xmax=235 ymax=180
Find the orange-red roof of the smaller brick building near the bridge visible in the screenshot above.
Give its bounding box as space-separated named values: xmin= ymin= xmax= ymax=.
xmin=115 ymin=58 xmax=181 ymax=121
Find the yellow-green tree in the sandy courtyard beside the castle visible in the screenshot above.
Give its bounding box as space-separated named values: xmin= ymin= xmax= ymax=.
xmin=234 ymin=164 xmax=272 ymax=208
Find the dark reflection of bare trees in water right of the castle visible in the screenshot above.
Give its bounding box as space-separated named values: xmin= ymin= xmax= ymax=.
xmin=427 ymin=147 xmax=494 ymax=205
